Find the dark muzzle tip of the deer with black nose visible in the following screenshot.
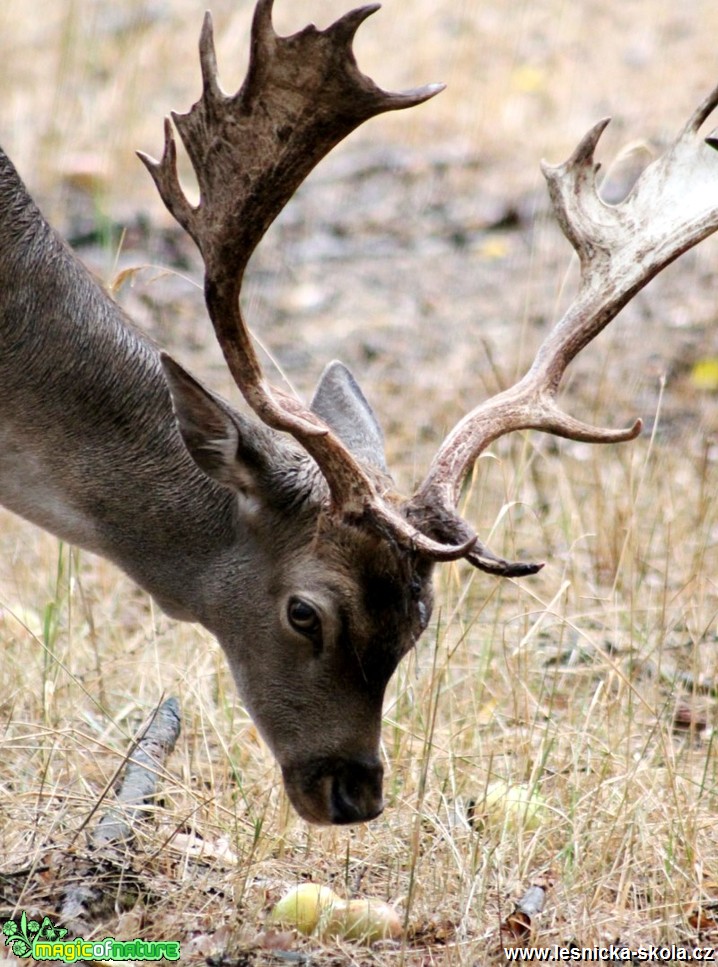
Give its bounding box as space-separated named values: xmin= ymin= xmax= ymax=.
xmin=282 ymin=756 xmax=384 ymax=826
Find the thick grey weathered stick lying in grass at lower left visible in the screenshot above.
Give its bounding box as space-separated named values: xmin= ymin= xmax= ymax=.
xmin=91 ymin=698 xmax=180 ymax=847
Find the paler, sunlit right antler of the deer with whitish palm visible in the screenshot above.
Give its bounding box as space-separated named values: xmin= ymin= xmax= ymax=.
xmin=405 ymin=87 xmax=718 ymax=570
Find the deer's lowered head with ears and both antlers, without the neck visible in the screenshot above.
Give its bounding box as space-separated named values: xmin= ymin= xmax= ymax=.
xmin=135 ymin=0 xmax=718 ymax=823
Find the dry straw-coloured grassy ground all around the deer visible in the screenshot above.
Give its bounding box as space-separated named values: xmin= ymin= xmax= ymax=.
xmin=0 ymin=0 xmax=718 ymax=965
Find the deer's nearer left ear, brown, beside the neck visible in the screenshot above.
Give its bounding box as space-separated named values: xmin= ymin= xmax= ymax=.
xmin=161 ymin=353 xmax=278 ymax=496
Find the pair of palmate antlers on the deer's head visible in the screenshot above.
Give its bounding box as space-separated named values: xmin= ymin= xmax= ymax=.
xmin=140 ymin=0 xmax=718 ymax=576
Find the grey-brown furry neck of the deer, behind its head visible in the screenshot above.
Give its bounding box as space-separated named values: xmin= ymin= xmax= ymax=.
xmin=0 ymin=152 xmax=242 ymax=620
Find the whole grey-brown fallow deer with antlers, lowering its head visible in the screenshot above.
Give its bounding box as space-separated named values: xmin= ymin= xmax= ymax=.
xmin=0 ymin=0 xmax=718 ymax=824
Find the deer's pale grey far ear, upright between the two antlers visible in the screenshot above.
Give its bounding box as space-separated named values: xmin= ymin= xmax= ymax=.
xmin=311 ymin=360 xmax=388 ymax=473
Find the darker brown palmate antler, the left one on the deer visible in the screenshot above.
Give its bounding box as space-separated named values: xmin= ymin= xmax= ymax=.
xmin=139 ymin=0 xmax=476 ymax=560
